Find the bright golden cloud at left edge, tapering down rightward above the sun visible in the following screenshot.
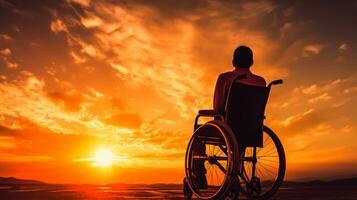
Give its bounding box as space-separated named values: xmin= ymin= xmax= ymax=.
xmin=0 ymin=71 xmax=135 ymax=136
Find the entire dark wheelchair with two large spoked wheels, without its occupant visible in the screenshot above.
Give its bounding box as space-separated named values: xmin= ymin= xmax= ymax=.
xmin=183 ymin=75 xmax=286 ymax=200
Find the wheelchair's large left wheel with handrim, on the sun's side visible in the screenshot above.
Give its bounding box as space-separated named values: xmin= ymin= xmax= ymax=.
xmin=185 ymin=120 xmax=239 ymax=199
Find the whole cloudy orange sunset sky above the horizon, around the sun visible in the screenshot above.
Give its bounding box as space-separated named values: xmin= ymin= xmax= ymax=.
xmin=0 ymin=0 xmax=357 ymax=183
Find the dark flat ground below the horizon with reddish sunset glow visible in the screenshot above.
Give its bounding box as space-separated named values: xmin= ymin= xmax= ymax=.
xmin=0 ymin=185 xmax=357 ymax=200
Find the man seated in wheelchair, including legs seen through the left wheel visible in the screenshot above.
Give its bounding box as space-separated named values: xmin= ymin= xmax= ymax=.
xmin=193 ymin=46 xmax=266 ymax=189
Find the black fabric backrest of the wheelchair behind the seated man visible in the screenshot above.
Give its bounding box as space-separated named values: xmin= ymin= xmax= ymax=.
xmin=225 ymin=81 xmax=270 ymax=147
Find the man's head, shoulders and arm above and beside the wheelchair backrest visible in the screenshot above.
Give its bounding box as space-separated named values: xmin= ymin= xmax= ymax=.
xmin=213 ymin=46 xmax=266 ymax=113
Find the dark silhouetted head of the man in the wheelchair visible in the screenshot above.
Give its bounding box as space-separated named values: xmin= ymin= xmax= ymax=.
xmin=232 ymin=46 xmax=253 ymax=68
